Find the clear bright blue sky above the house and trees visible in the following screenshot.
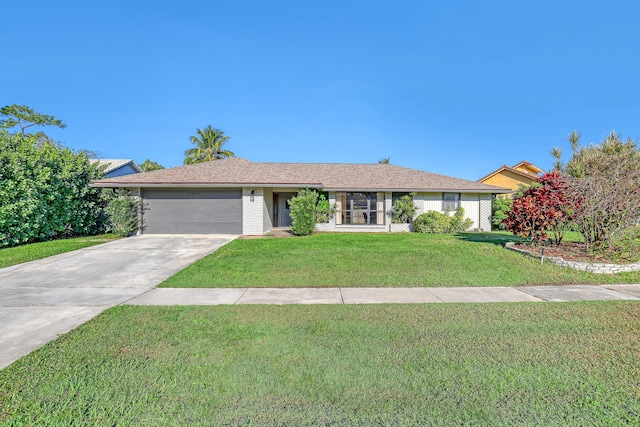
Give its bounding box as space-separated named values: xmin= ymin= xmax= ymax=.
xmin=5 ymin=0 xmax=640 ymax=180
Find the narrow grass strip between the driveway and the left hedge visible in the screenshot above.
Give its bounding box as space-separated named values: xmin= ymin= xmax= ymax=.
xmin=0 ymin=234 xmax=118 ymax=268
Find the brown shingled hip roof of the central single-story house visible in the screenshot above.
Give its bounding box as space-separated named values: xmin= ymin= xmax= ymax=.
xmin=93 ymin=157 xmax=511 ymax=193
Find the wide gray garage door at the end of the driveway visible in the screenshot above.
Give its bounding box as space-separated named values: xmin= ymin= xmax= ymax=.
xmin=142 ymin=189 xmax=242 ymax=234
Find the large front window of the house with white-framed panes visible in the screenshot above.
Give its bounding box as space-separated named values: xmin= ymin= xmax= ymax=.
xmin=336 ymin=193 xmax=384 ymax=225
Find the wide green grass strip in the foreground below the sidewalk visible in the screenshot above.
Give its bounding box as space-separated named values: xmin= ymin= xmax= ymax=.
xmin=0 ymin=301 xmax=640 ymax=426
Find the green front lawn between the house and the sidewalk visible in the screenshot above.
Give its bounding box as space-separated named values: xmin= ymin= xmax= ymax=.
xmin=160 ymin=233 xmax=640 ymax=288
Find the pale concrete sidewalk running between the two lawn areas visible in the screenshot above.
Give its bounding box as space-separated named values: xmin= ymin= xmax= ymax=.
xmin=125 ymin=285 xmax=640 ymax=305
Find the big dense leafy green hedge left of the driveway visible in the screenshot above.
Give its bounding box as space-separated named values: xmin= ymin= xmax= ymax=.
xmin=0 ymin=128 xmax=104 ymax=247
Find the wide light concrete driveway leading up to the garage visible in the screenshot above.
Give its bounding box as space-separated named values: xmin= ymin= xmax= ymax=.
xmin=0 ymin=234 xmax=237 ymax=369
